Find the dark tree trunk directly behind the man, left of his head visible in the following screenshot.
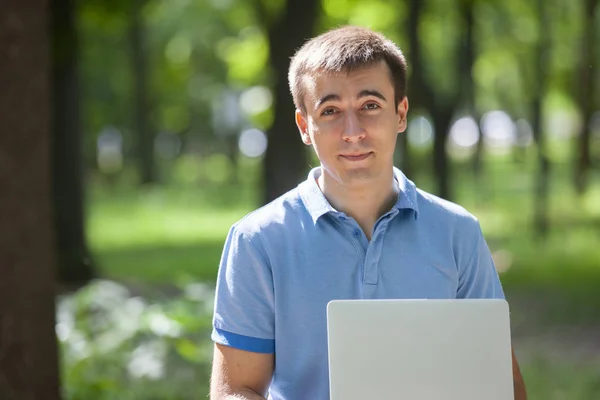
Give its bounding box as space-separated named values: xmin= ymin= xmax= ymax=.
xmin=263 ymin=0 xmax=320 ymax=203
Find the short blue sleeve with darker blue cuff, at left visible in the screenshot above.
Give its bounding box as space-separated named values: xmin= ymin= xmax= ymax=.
xmin=211 ymin=225 xmax=275 ymax=353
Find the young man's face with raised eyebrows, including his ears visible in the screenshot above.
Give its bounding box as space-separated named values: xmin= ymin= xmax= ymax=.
xmin=296 ymin=61 xmax=408 ymax=184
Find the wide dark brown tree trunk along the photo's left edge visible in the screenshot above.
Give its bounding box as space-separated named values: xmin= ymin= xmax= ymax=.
xmin=0 ymin=0 xmax=60 ymax=400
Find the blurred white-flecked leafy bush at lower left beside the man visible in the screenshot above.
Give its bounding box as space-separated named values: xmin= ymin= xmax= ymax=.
xmin=56 ymin=280 xmax=214 ymax=400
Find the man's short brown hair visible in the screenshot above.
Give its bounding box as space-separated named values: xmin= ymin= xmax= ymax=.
xmin=288 ymin=26 xmax=406 ymax=112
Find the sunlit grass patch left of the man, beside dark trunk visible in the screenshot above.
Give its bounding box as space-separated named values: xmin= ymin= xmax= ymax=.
xmin=88 ymin=187 xmax=248 ymax=283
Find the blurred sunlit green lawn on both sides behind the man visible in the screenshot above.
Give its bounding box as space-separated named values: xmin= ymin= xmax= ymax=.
xmin=88 ymin=156 xmax=600 ymax=291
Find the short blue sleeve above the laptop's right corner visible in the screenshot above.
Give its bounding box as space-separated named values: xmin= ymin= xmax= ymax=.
xmin=456 ymin=222 xmax=504 ymax=299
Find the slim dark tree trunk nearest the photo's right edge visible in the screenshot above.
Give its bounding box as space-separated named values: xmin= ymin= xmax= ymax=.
xmin=574 ymin=0 xmax=598 ymax=195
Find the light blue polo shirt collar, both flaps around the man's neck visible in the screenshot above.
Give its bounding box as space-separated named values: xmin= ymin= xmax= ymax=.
xmin=299 ymin=167 xmax=419 ymax=224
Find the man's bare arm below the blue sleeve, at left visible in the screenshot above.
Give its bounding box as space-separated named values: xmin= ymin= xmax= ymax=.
xmin=210 ymin=344 xmax=275 ymax=400
